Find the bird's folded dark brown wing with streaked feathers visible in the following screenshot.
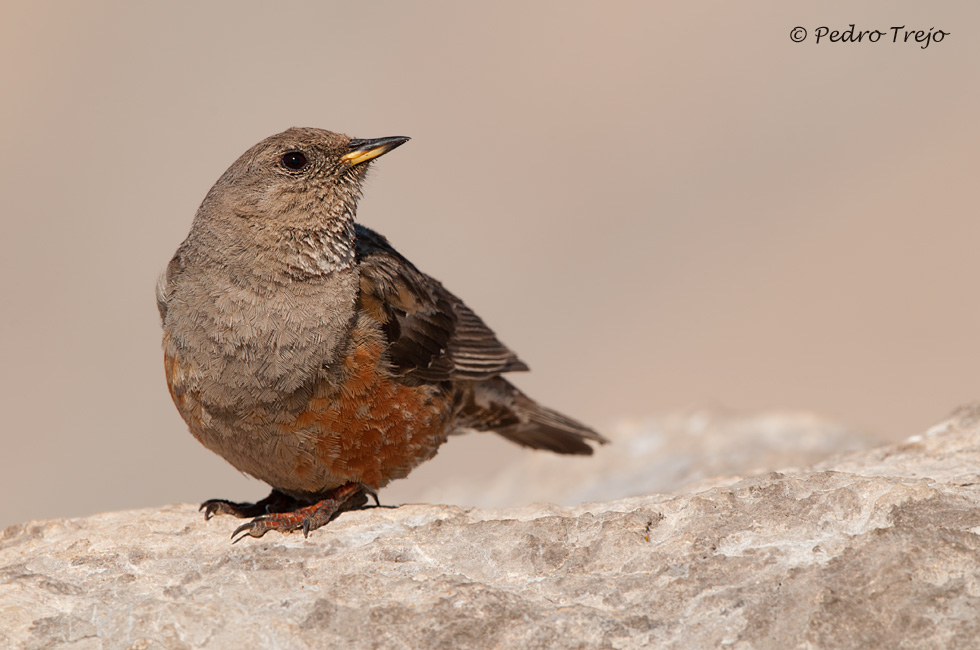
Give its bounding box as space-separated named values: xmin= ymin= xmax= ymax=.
xmin=356 ymin=225 xmax=528 ymax=381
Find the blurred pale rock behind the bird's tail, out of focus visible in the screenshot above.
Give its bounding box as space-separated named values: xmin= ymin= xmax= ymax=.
xmin=382 ymin=410 xmax=882 ymax=508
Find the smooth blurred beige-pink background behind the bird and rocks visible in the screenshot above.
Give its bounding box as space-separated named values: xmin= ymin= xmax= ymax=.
xmin=0 ymin=0 xmax=980 ymax=525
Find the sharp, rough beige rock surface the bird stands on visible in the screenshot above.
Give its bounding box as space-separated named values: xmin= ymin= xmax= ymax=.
xmin=0 ymin=408 xmax=980 ymax=649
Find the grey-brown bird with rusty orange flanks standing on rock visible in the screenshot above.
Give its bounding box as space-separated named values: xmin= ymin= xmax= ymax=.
xmin=156 ymin=128 xmax=608 ymax=542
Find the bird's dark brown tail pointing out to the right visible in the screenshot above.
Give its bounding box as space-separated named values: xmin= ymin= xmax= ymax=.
xmin=456 ymin=377 xmax=609 ymax=455
